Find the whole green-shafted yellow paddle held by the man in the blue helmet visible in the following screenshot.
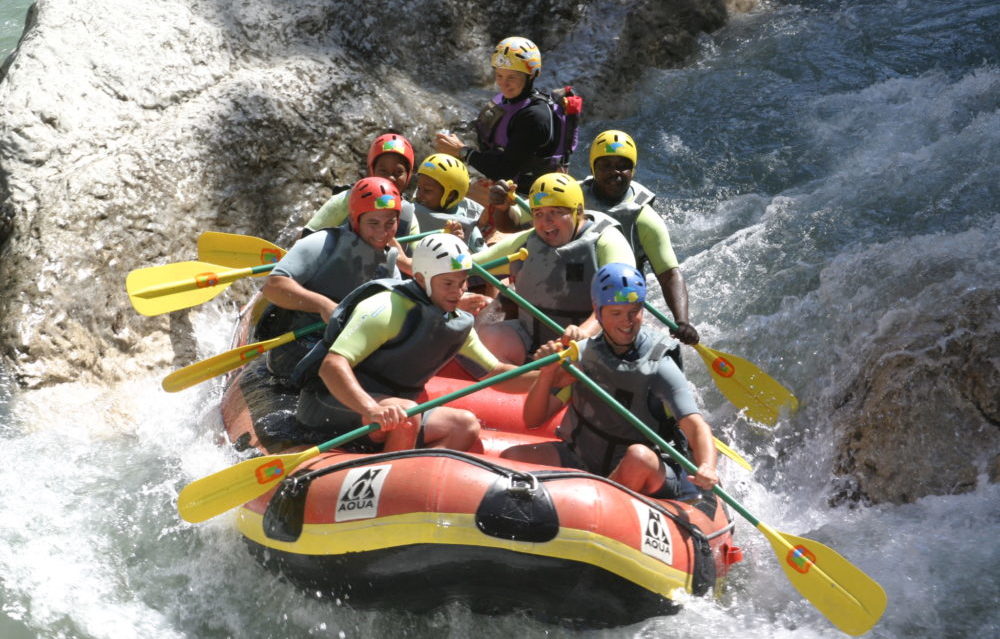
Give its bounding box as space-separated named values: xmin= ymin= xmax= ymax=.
xmin=563 ymin=361 xmax=886 ymax=635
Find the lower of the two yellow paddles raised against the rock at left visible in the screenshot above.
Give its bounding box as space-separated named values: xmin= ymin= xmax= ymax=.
xmin=125 ymin=229 xmax=441 ymax=316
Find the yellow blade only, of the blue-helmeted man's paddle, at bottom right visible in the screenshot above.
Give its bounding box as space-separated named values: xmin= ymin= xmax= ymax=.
xmin=757 ymin=522 xmax=887 ymax=635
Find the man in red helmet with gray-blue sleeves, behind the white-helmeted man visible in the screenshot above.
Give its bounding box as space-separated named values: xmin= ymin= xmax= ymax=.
xmin=255 ymin=177 xmax=402 ymax=378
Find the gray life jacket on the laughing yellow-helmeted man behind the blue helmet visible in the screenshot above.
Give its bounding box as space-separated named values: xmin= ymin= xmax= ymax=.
xmin=511 ymin=211 xmax=618 ymax=350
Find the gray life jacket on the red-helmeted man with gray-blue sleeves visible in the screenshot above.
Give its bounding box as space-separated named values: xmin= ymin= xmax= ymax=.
xmin=254 ymin=223 xmax=397 ymax=341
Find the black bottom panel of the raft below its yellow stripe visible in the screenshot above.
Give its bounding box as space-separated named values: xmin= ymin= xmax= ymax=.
xmin=244 ymin=538 xmax=679 ymax=627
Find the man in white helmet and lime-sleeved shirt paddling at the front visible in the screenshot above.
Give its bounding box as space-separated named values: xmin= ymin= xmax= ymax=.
xmin=295 ymin=234 xmax=537 ymax=452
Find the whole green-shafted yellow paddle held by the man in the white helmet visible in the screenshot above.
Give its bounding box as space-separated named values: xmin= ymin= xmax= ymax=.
xmin=177 ymin=344 xmax=579 ymax=523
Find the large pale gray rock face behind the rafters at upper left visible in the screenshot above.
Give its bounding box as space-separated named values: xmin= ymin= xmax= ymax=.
xmin=0 ymin=0 xmax=724 ymax=387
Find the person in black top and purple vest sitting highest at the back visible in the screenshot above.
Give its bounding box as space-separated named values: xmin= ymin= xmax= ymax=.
xmin=434 ymin=37 xmax=582 ymax=201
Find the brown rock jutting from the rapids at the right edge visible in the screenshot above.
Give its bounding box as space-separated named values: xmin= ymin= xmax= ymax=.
xmin=832 ymin=289 xmax=1000 ymax=504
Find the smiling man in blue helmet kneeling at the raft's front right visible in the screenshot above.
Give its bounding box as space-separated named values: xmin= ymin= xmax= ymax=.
xmin=501 ymin=264 xmax=719 ymax=499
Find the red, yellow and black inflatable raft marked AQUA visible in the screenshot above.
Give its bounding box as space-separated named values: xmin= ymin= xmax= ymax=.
xmin=222 ymin=304 xmax=740 ymax=626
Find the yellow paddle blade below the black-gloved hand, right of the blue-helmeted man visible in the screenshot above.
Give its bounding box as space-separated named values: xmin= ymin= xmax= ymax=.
xmin=694 ymin=344 xmax=799 ymax=426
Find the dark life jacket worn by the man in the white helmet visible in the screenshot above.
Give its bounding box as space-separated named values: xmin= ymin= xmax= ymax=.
xmin=292 ymin=279 xmax=475 ymax=399
